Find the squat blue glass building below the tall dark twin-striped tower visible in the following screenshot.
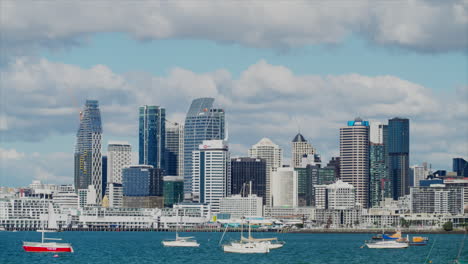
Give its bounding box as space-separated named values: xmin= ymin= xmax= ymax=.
xmin=122 ymin=165 xmax=164 ymax=196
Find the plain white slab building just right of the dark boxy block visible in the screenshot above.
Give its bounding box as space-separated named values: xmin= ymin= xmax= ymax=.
xmin=271 ymin=167 xmax=298 ymax=207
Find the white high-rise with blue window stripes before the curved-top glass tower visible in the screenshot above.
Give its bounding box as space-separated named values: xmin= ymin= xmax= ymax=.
xmin=192 ymin=140 xmax=231 ymax=213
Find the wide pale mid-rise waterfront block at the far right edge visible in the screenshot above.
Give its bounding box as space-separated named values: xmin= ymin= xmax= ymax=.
xmin=410 ymin=184 xmax=464 ymax=215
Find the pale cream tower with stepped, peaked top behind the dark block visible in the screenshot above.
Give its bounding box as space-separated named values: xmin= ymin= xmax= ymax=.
xmin=249 ymin=138 xmax=283 ymax=205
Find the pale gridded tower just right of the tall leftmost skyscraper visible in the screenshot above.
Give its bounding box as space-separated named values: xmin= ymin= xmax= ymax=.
xmin=107 ymin=141 xmax=132 ymax=184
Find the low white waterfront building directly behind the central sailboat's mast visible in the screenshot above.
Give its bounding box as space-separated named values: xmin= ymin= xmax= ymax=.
xmin=219 ymin=194 xmax=263 ymax=219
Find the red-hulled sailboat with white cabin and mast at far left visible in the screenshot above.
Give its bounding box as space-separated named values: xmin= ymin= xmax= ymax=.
xmin=23 ymin=203 xmax=73 ymax=253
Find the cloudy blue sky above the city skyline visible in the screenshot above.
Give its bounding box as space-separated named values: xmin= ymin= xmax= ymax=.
xmin=0 ymin=0 xmax=468 ymax=186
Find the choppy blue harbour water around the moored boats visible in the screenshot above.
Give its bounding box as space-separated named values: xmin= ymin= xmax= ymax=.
xmin=0 ymin=232 xmax=468 ymax=264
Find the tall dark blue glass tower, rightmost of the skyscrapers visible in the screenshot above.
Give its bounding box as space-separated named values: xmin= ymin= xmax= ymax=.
xmin=386 ymin=117 xmax=410 ymax=200
